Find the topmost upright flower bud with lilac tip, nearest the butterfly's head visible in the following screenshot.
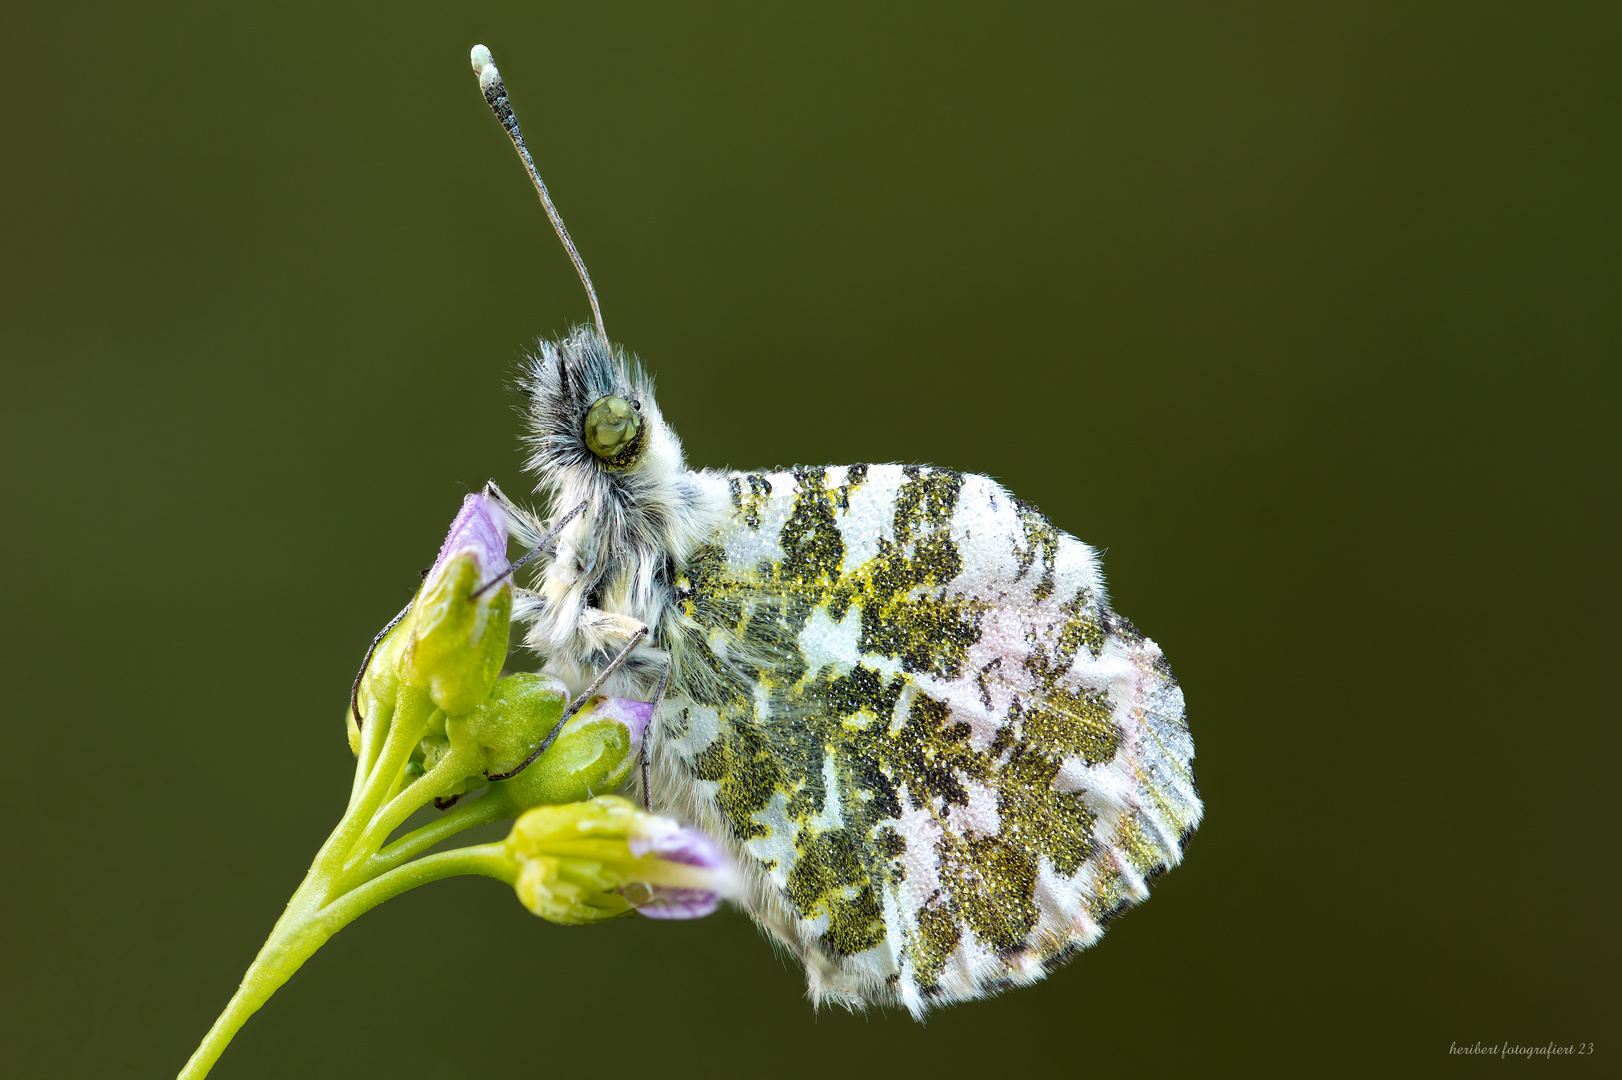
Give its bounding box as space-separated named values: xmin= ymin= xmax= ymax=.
xmin=399 ymin=495 xmax=513 ymax=717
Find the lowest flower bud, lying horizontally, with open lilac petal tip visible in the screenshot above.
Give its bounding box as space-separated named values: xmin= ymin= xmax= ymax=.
xmin=504 ymin=795 xmax=736 ymax=926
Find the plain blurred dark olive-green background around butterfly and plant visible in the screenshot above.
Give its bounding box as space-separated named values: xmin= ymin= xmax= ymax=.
xmin=0 ymin=2 xmax=1622 ymax=1078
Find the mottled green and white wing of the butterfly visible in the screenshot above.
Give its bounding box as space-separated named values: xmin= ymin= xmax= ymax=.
xmin=654 ymin=465 xmax=1200 ymax=1014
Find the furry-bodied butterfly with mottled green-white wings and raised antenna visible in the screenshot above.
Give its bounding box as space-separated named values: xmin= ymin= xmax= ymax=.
xmin=472 ymin=45 xmax=1202 ymax=1017
